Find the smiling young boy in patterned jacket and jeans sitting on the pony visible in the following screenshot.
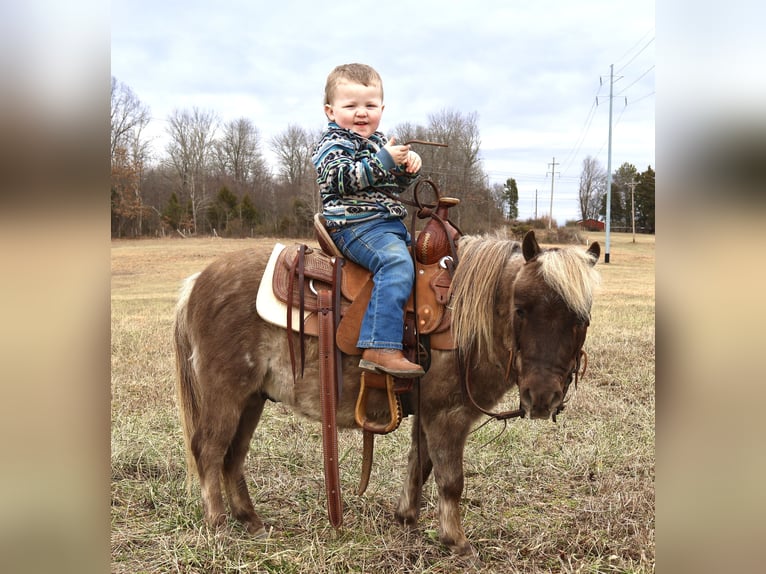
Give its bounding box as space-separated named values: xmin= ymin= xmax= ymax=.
xmin=312 ymin=64 xmax=424 ymax=378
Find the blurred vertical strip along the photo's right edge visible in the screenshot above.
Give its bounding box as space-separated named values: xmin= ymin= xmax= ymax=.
xmin=656 ymin=0 xmax=766 ymax=573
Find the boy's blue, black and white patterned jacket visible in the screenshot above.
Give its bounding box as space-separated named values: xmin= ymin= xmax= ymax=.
xmin=311 ymin=122 xmax=418 ymax=229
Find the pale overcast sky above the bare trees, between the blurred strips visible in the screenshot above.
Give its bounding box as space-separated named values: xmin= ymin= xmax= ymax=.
xmin=111 ymin=0 xmax=655 ymax=223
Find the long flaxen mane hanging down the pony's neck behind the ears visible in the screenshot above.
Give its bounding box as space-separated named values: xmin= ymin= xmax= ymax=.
xmin=450 ymin=235 xmax=521 ymax=357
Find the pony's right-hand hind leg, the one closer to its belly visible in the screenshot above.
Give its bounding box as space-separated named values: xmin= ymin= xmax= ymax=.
xmin=223 ymin=395 xmax=266 ymax=537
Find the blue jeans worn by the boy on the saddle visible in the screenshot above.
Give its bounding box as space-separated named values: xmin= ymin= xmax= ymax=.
xmin=331 ymin=219 xmax=415 ymax=349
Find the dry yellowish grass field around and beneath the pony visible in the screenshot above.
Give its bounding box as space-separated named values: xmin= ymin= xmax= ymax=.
xmin=111 ymin=233 xmax=655 ymax=573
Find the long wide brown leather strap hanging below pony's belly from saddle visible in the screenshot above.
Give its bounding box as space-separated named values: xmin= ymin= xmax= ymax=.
xmin=319 ymin=289 xmax=343 ymax=529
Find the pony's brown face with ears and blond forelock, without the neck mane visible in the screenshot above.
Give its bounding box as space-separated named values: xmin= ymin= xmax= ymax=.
xmin=509 ymin=231 xmax=601 ymax=420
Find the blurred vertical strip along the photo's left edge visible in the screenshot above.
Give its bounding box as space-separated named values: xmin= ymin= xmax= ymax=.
xmin=0 ymin=0 xmax=110 ymax=574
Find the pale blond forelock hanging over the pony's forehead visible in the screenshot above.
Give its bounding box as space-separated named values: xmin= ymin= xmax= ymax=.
xmin=537 ymin=247 xmax=600 ymax=320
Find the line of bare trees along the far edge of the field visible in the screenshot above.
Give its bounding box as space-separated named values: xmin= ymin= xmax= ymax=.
xmin=111 ymin=77 xmax=654 ymax=237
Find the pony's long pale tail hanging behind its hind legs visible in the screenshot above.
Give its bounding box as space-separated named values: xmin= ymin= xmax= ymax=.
xmin=173 ymin=273 xmax=199 ymax=492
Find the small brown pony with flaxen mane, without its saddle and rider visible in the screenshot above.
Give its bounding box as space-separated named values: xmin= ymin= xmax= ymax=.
xmin=175 ymin=232 xmax=600 ymax=554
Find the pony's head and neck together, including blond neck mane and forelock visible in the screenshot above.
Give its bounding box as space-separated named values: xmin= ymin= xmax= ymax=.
xmin=451 ymin=231 xmax=601 ymax=420
